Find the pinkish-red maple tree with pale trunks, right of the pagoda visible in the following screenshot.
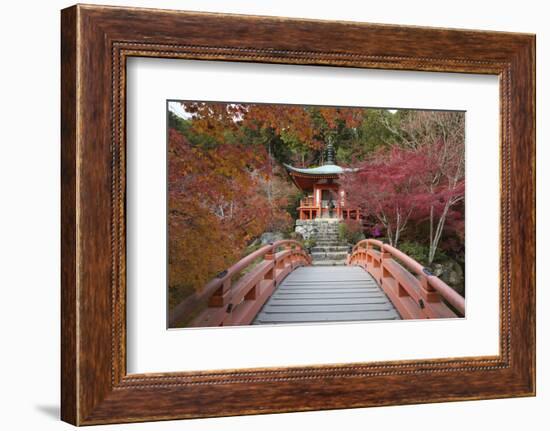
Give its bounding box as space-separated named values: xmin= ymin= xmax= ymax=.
xmin=343 ymin=111 xmax=465 ymax=264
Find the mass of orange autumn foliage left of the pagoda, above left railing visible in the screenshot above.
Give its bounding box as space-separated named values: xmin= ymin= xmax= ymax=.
xmin=168 ymin=129 xmax=292 ymax=296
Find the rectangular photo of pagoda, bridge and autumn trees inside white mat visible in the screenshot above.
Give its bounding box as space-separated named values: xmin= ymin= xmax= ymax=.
xmin=166 ymin=100 xmax=466 ymax=328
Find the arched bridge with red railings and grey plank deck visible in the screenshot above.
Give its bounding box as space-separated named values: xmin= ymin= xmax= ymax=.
xmin=170 ymin=239 xmax=465 ymax=327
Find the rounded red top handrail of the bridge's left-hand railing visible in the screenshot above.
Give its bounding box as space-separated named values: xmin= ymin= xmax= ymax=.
xmin=170 ymin=239 xmax=311 ymax=326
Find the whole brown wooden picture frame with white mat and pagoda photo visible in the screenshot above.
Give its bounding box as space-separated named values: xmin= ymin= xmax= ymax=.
xmin=61 ymin=5 xmax=535 ymax=425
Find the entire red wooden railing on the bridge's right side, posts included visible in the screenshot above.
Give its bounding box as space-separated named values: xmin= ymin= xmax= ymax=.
xmin=347 ymin=239 xmax=465 ymax=319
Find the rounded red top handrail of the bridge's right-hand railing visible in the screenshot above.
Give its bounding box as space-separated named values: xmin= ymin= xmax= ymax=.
xmin=348 ymin=238 xmax=466 ymax=316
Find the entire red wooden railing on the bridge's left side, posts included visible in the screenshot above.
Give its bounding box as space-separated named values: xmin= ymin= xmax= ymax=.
xmin=170 ymin=240 xmax=311 ymax=327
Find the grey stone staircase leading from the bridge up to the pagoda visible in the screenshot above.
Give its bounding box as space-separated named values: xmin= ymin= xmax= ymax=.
xmin=311 ymin=220 xmax=348 ymax=266
